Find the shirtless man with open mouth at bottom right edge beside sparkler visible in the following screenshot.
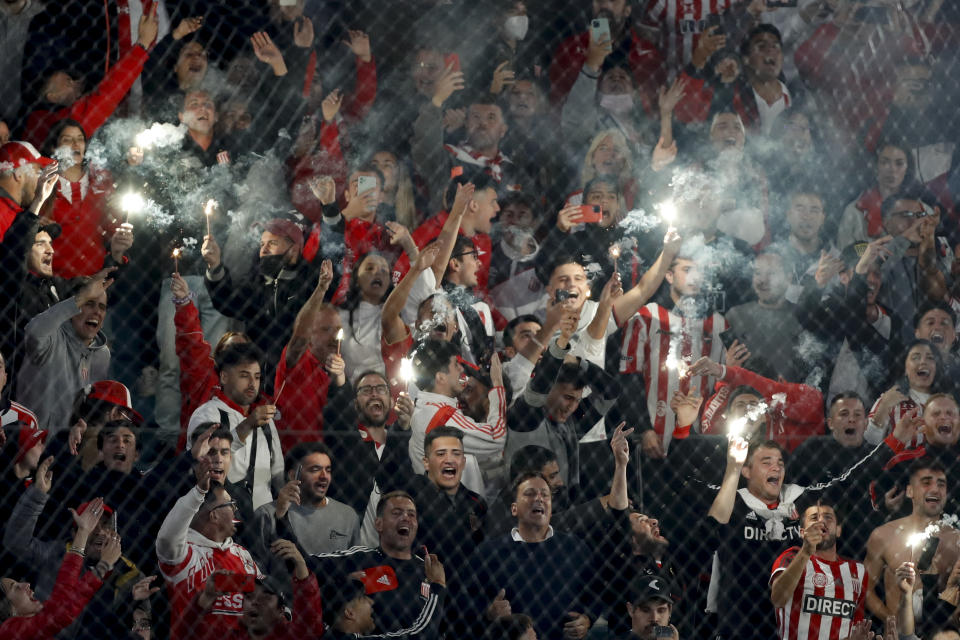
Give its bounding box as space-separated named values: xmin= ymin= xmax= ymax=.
xmin=863 ymin=457 xmax=960 ymax=619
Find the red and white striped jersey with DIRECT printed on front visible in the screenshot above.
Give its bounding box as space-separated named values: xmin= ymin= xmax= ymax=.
xmin=770 ymin=547 xmax=867 ymax=640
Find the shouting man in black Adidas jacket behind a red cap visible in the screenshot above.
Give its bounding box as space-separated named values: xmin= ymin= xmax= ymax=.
xmin=307 ymin=491 xmax=430 ymax=632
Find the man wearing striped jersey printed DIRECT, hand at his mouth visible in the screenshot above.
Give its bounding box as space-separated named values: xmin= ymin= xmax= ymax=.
xmin=770 ymin=501 xmax=867 ymax=640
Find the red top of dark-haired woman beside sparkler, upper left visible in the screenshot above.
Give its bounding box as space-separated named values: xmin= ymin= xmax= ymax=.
xmin=53 ymin=171 xmax=117 ymax=278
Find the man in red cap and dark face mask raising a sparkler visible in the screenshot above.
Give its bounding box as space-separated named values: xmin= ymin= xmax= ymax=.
xmin=201 ymin=218 xmax=336 ymax=391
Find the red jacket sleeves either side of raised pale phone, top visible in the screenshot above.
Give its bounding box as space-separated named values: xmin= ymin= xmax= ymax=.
xmin=549 ymin=28 xmax=667 ymax=112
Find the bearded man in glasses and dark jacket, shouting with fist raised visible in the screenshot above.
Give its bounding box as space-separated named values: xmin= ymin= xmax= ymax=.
xmin=324 ymin=371 xmax=413 ymax=547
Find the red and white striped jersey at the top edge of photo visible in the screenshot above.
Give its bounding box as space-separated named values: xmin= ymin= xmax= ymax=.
xmin=644 ymin=0 xmax=733 ymax=72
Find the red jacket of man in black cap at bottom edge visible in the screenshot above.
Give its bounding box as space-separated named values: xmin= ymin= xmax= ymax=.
xmin=172 ymin=573 xmax=323 ymax=640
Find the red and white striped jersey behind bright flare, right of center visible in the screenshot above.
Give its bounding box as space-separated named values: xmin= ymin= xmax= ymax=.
xmin=620 ymin=302 xmax=728 ymax=447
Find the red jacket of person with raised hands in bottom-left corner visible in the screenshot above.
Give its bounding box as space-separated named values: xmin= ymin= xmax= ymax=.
xmin=0 ymin=553 xmax=103 ymax=640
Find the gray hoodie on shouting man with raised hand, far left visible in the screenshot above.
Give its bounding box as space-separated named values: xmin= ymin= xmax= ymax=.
xmin=17 ymin=298 xmax=110 ymax=434
